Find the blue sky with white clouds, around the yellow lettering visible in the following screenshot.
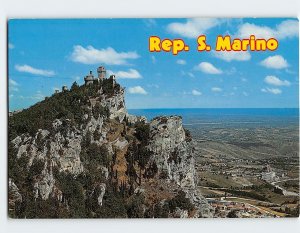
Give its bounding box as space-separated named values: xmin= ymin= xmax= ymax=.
xmin=8 ymin=18 xmax=299 ymax=110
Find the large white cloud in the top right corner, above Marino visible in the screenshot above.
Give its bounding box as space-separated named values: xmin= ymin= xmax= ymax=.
xmin=237 ymin=20 xmax=299 ymax=39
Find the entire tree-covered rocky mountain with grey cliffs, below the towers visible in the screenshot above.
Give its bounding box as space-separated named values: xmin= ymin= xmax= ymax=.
xmin=9 ymin=69 xmax=212 ymax=218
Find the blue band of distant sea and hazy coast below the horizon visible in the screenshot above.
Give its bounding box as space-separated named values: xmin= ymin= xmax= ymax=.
xmin=128 ymin=108 xmax=299 ymax=128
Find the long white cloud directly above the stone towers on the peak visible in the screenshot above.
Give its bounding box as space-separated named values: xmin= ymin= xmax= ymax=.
xmin=70 ymin=45 xmax=139 ymax=65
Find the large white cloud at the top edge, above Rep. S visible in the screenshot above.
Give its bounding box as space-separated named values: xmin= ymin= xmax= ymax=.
xmin=167 ymin=18 xmax=225 ymax=38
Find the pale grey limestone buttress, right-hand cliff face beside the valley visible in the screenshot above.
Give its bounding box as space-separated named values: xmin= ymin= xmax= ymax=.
xmin=149 ymin=116 xmax=213 ymax=217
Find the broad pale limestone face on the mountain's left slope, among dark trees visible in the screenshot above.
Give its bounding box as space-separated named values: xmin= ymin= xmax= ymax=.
xmin=12 ymin=124 xmax=83 ymax=174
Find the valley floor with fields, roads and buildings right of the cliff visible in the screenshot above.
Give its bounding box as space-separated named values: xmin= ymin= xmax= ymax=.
xmin=190 ymin=127 xmax=299 ymax=217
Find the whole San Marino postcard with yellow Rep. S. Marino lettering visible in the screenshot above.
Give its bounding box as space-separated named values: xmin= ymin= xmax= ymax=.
xmin=7 ymin=18 xmax=299 ymax=219
